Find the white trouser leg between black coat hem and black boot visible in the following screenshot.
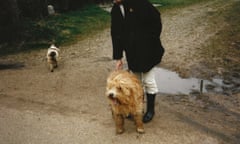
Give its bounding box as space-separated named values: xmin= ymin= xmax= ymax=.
xmin=133 ymin=68 xmax=158 ymax=94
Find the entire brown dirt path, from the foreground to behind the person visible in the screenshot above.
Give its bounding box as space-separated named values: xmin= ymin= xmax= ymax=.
xmin=0 ymin=0 xmax=240 ymax=144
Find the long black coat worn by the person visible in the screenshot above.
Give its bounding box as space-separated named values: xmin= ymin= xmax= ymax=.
xmin=111 ymin=0 xmax=164 ymax=72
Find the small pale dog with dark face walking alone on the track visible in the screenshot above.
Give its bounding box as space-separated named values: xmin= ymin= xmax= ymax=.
xmin=47 ymin=44 xmax=60 ymax=72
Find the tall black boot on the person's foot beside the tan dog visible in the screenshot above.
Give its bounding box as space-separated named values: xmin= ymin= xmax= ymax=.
xmin=143 ymin=94 xmax=156 ymax=123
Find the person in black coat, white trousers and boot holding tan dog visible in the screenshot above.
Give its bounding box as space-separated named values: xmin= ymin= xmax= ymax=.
xmin=111 ymin=0 xmax=164 ymax=123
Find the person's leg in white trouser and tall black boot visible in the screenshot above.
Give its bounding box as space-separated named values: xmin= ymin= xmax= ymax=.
xmin=142 ymin=69 xmax=158 ymax=123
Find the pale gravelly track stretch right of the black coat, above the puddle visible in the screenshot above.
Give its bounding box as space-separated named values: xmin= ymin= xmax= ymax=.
xmin=162 ymin=0 xmax=233 ymax=77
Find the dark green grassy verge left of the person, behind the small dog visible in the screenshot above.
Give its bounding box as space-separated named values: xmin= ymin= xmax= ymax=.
xmin=0 ymin=5 xmax=110 ymax=55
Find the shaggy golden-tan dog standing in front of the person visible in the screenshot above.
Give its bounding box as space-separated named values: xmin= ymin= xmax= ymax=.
xmin=106 ymin=70 xmax=144 ymax=134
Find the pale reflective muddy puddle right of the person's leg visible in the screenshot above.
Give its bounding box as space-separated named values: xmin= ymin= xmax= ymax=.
xmin=155 ymin=68 xmax=240 ymax=95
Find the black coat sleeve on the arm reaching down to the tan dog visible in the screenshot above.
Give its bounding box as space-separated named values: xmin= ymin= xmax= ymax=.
xmin=111 ymin=5 xmax=124 ymax=60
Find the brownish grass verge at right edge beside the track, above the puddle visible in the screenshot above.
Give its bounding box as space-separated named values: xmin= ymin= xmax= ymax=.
xmin=203 ymin=1 xmax=240 ymax=73
